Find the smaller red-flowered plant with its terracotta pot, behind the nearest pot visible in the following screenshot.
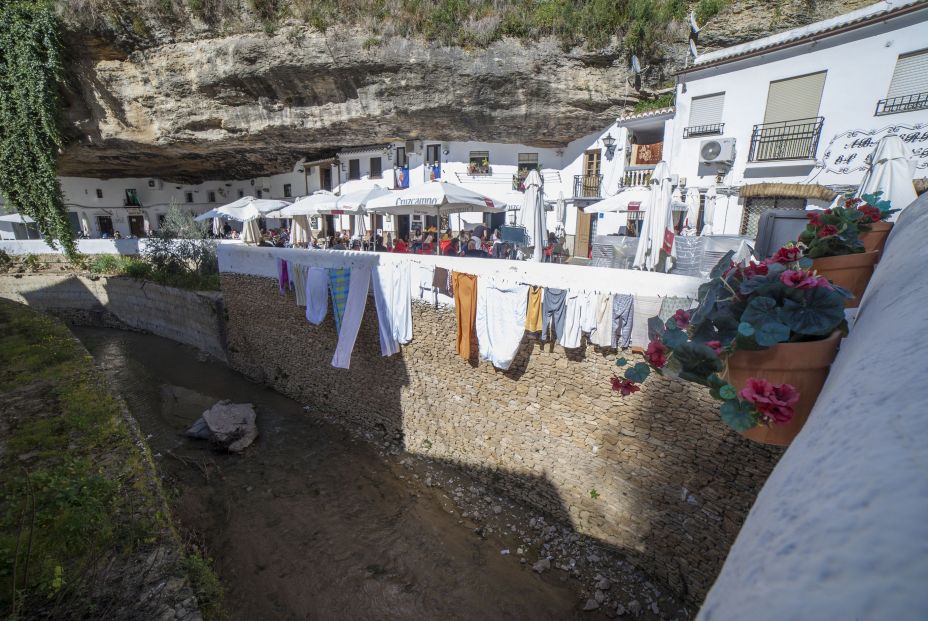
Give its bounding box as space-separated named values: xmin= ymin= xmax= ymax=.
xmin=799 ymin=204 xmax=880 ymax=308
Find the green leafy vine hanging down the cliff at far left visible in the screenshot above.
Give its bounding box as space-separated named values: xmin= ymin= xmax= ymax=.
xmin=0 ymin=0 xmax=75 ymax=256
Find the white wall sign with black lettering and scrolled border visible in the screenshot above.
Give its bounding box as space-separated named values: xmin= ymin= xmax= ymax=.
xmin=822 ymin=123 xmax=928 ymax=175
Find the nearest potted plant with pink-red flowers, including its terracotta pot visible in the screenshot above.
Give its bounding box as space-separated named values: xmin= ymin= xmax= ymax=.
xmin=612 ymin=245 xmax=849 ymax=446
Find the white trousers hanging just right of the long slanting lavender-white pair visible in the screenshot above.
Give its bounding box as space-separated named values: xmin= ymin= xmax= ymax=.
xmin=373 ymin=262 xmax=412 ymax=356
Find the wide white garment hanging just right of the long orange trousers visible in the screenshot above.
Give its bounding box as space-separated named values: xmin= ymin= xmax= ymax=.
xmin=476 ymin=277 xmax=528 ymax=370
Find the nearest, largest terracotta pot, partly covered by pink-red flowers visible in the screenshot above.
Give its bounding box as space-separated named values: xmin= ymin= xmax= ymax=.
xmin=725 ymin=330 xmax=841 ymax=446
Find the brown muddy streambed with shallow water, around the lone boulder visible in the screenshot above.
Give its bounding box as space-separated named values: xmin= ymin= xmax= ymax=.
xmin=74 ymin=328 xmax=687 ymax=621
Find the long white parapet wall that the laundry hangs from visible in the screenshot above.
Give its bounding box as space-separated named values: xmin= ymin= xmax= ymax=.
xmin=219 ymin=244 xmax=703 ymax=345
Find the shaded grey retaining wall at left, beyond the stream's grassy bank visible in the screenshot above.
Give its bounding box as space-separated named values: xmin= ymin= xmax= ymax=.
xmin=0 ymin=272 xmax=226 ymax=362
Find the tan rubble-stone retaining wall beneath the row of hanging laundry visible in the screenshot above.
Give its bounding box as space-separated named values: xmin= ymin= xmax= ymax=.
xmin=222 ymin=273 xmax=782 ymax=602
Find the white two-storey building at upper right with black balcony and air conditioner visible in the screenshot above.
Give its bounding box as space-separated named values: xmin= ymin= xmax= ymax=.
xmin=664 ymin=0 xmax=928 ymax=236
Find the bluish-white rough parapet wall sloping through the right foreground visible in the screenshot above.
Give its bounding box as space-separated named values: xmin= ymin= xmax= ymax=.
xmin=698 ymin=194 xmax=928 ymax=621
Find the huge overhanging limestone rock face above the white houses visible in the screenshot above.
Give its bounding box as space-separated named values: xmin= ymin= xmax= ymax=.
xmin=60 ymin=0 xmax=866 ymax=181
